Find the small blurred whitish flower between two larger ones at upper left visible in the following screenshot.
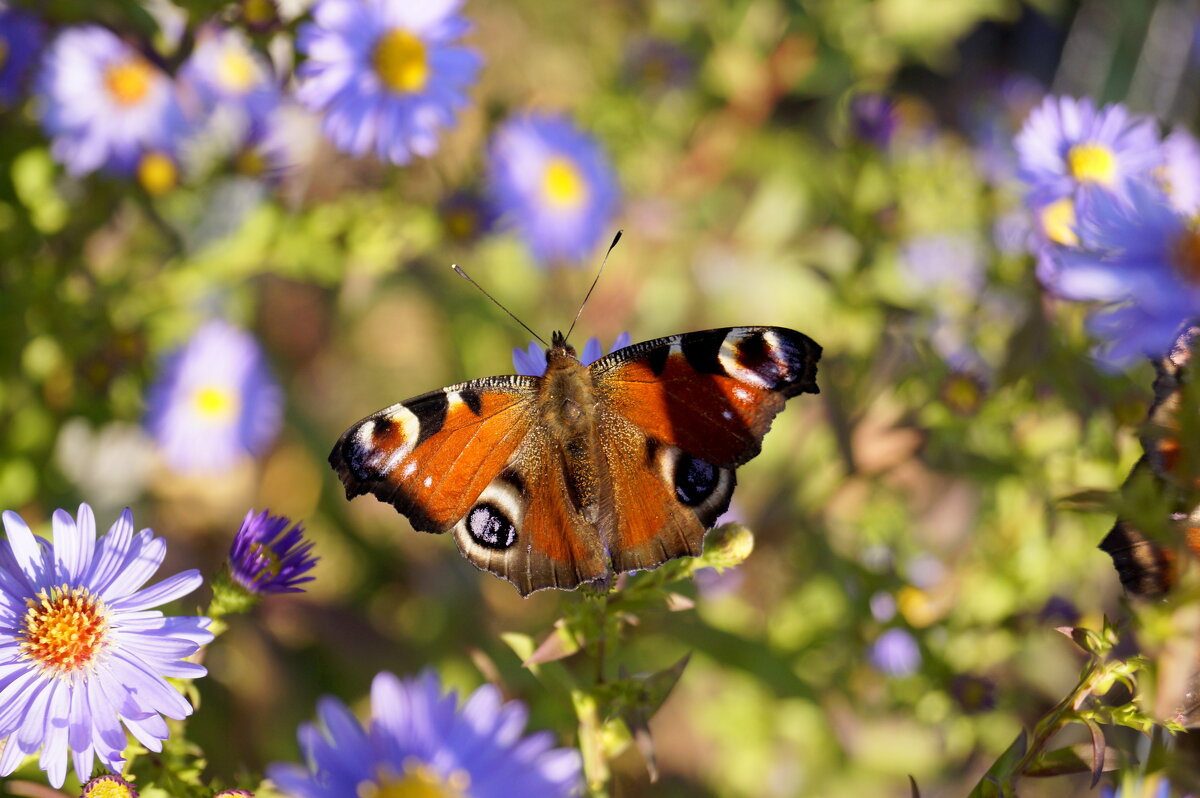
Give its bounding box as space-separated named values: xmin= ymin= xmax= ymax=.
xmin=179 ymin=28 xmax=280 ymax=136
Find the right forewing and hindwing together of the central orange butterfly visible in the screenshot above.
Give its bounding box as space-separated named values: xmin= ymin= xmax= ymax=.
xmin=592 ymin=326 xmax=821 ymax=572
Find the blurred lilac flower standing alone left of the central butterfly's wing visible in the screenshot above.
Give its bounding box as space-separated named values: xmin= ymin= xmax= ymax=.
xmin=146 ymin=319 xmax=283 ymax=472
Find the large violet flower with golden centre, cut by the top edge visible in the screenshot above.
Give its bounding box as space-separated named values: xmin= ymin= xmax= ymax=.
xmin=296 ymin=0 xmax=481 ymax=164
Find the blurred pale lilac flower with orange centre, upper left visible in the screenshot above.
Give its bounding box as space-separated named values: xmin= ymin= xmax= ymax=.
xmin=37 ymin=25 xmax=187 ymax=175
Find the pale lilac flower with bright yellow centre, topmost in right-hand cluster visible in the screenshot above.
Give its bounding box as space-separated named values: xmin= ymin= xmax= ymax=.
xmin=1016 ymin=97 xmax=1163 ymax=209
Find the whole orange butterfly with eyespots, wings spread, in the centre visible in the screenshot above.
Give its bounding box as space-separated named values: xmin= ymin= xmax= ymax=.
xmin=329 ymin=326 xmax=821 ymax=595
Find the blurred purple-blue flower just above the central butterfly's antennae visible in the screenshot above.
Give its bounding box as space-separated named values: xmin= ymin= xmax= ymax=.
xmin=488 ymin=114 xmax=617 ymax=263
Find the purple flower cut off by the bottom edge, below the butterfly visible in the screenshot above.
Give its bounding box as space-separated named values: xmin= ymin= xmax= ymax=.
xmin=268 ymin=672 xmax=581 ymax=798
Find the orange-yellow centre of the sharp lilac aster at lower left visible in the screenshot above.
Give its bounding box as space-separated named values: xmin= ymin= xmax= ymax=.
xmin=17 ymin=584 xmax=108 ymax=677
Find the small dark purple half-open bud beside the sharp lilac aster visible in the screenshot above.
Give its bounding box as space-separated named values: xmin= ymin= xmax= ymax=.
xmin=229 ymin=510 xmax=317 ymax=593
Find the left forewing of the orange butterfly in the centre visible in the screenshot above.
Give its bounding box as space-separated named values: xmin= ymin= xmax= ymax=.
xmin=329 ymin=377 xmax=536 ymax=533
